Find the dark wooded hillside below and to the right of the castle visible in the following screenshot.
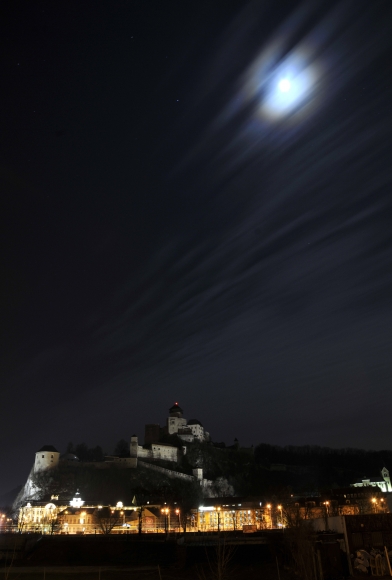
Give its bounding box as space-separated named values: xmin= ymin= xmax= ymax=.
xmin=16 ymin=438 xmax=392 ymax=504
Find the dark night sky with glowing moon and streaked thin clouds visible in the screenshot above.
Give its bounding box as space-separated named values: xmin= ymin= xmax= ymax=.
xmin=0 ymin=0 xmax=392 ymax=493
